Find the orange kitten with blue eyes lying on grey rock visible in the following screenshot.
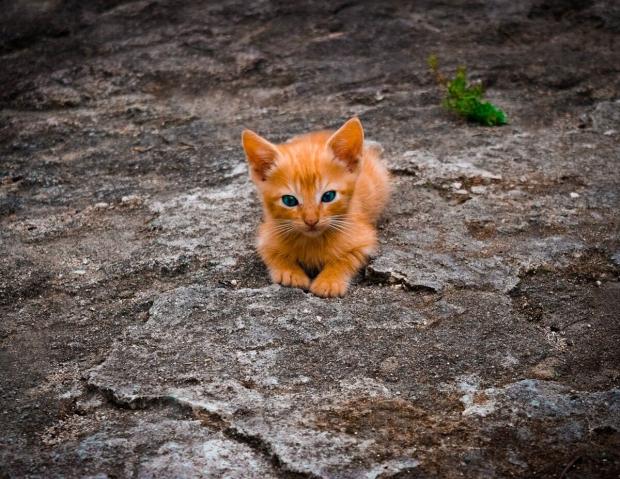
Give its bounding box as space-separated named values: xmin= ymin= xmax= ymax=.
xmin=241 ymin=118 xmax=390 ymax=297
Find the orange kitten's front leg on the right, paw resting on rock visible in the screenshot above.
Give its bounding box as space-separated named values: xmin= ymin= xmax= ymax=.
xmin=310 ymin=248 xmax=367 ymax=298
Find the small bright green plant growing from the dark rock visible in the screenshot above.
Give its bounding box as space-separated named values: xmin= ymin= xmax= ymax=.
xmin=428 ymin=55 xmax=508 ymax=126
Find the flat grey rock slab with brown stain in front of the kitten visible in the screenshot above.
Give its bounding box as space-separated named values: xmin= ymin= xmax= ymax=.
xmin=88 ymin=286 xmax=620 ymax=478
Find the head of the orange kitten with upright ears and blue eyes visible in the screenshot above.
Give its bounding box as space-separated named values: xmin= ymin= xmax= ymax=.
xmin=242 ymin=118 xmax=364 ymax=237
